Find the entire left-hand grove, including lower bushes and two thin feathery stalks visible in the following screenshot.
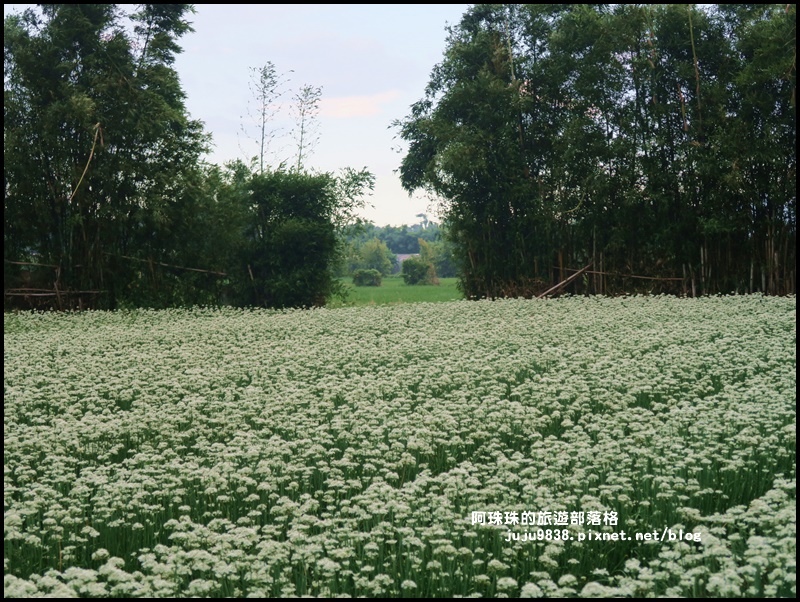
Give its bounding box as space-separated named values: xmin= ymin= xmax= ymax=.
xmin=3 ymin=4 xmax=374 ymax=309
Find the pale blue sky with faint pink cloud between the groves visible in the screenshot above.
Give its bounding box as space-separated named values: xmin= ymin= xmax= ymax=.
xmin=4 ymin=4 xmax=468 ymax=225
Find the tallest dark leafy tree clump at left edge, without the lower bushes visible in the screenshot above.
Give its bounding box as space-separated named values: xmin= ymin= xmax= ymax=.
xmin=3 ymin=4 xmax=206 ymax=307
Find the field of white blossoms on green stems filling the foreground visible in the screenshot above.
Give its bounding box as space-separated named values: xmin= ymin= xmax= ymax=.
xmin=3 ymin=296 xmax=797 ymax=597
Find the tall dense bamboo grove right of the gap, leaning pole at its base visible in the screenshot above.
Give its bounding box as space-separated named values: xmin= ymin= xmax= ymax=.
xmin=395 ymin=4 xmax=797 ymax=297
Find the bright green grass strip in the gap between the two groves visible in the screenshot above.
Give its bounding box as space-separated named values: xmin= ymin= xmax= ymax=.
xmin=328 ymin=276 xmax=464 ymax=308
